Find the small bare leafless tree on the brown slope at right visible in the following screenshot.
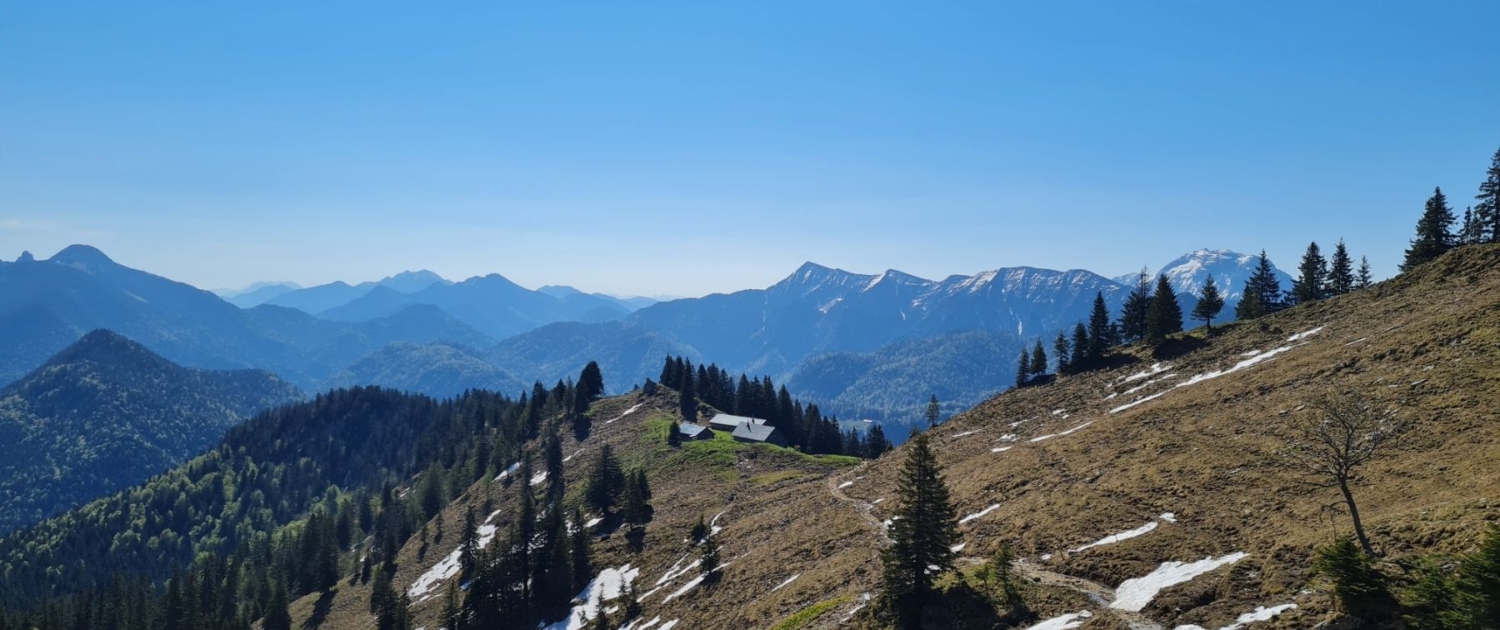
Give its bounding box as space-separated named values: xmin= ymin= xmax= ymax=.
xmin=1284 ymin=392 xmax=1412 ymax=555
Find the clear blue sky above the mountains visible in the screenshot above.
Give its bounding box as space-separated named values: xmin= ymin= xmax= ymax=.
xmin=0 ymin=0 xmax=1500 ymax=296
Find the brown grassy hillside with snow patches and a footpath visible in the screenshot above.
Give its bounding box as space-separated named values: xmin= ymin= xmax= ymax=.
xmin=294 ymin=246 xmax=1500 ymax=629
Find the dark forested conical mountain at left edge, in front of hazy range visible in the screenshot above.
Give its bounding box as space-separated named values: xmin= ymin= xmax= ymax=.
xmin=0 ymin=330 xmax=303 ymax=533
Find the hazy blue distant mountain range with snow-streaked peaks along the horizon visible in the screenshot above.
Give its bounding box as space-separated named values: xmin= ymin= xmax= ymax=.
xmin=0 ymin=246 xmax=1286 ymax=422
